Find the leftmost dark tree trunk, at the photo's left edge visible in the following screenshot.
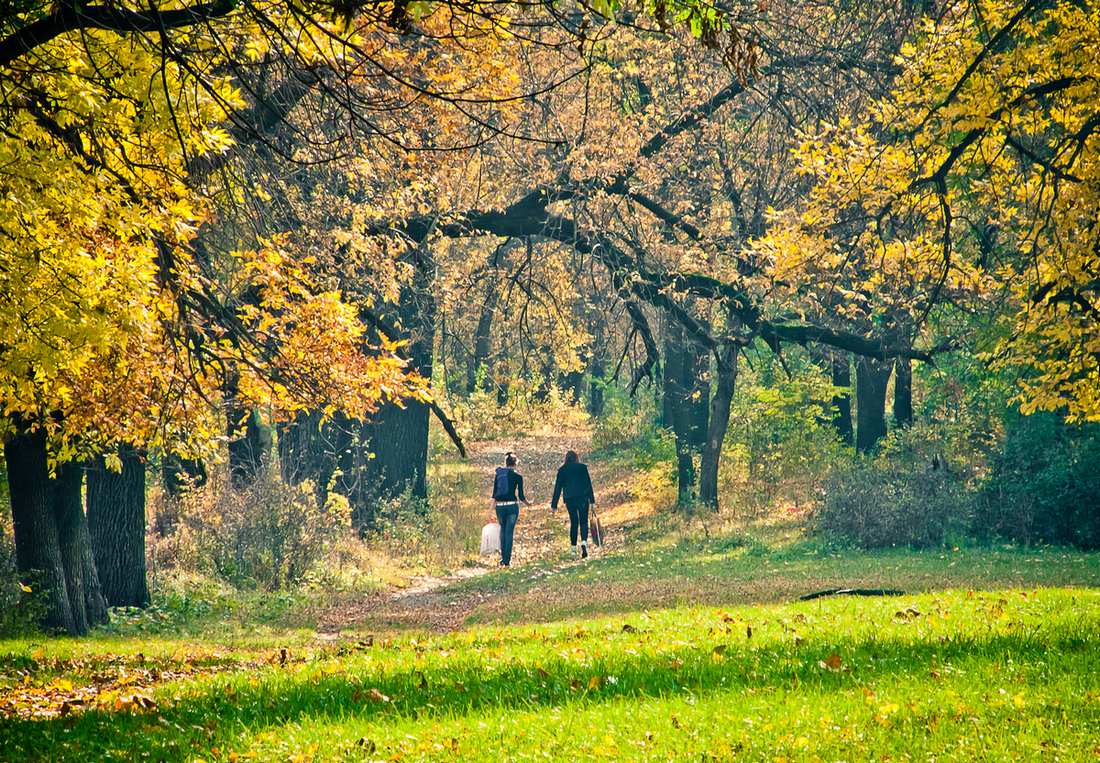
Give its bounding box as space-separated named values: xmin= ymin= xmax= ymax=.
xmin=3 ymin=423 xmax=77 ymax=634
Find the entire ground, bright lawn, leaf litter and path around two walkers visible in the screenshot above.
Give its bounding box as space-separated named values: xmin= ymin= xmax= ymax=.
xmin=0 ymin=433 xmax=1100 ymax=762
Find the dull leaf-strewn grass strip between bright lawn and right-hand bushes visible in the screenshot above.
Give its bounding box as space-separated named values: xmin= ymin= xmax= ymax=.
xmin=424 ymin=534 xmax=1100 ymax=623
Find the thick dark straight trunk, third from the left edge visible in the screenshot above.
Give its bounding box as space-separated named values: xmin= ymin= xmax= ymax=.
xmin=88 ymin=445 xmax=149 ymax=607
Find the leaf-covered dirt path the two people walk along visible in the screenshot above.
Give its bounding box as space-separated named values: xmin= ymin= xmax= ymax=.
xmin=320 ymin=431 xmax=625 ymax=632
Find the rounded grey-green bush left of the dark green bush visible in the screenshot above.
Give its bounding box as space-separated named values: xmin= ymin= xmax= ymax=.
xmin=815 ymin=427 xmax=972 ymax=549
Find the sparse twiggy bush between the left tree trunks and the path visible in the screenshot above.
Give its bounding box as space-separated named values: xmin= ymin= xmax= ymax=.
xmin=152 ymin=474 xmax=351 ymax=590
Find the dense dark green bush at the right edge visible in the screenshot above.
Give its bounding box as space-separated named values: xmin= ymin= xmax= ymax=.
xmin=974 ymin=413 xmax=1100 ymax=549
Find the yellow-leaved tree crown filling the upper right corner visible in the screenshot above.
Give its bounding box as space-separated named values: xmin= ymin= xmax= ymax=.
xmin=787 ymin=0 xmax=1100 ymax=421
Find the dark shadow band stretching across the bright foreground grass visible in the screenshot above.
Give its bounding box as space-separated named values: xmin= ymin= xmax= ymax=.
xmin=0 ymin=632 xmax=1100 ymax=761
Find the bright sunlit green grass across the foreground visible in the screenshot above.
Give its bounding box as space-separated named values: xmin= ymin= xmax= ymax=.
xmin=0 ymin=589 xmax=1100 ymax=761
